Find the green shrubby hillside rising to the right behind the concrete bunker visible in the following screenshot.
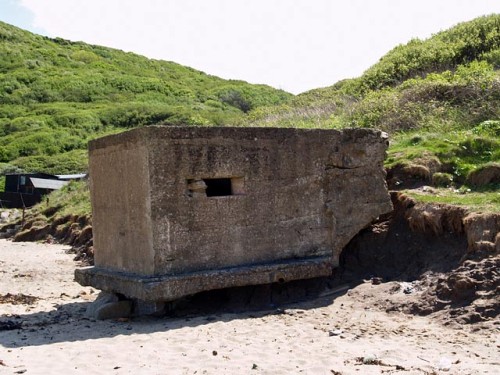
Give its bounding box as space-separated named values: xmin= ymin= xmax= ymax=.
xmin=247 ymin=15 xmax=500 ymax=207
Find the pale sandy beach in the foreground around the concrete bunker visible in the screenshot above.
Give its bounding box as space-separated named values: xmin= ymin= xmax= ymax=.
xmin=0 ymin=240 xmax=500 ymax=375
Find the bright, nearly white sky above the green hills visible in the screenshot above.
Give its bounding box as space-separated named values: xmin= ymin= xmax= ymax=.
xmin=0 ymin=0 xmax=500 ymax=94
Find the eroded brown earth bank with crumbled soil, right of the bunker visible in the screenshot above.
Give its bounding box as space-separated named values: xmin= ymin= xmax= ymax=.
xmin=339 ymin=193 xmax=500 ymax=324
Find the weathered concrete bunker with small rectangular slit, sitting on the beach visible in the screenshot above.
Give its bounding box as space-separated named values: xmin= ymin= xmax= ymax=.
xmin=77 ymin=127 xmax=392 ymax=299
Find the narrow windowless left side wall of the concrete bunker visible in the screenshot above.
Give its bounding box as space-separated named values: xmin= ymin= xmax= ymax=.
xmin=89 ymin=134 xmax=155 ymax=275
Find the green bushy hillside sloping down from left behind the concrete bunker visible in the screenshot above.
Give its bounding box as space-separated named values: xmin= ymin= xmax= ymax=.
xmin=0 ymin=22 xmax=292 ymax=175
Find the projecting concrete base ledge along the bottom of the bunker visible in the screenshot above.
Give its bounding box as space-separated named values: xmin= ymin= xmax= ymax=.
xmin=75 ymin=257 xmax=333 ymax=302
